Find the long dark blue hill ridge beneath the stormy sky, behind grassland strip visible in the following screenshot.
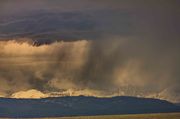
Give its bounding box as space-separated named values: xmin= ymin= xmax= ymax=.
xmin=0 ymin=96 xmax=180 ymax=118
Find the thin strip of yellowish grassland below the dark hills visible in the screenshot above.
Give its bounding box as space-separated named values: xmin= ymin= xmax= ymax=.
xmin=40 ymin=113 xmax=180 ymax=119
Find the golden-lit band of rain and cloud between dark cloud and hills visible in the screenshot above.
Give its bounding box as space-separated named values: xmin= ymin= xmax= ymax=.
xmin=0 ymin=38 xmax=180 ymax=102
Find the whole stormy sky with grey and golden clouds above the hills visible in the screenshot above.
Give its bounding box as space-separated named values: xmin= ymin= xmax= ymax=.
xmin=0 ymin=0 xmax=180 ymax=102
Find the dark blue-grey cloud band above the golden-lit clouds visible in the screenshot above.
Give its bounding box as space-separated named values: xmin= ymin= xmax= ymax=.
xmin=0 ymin=10 xmax=134 ymax=44
